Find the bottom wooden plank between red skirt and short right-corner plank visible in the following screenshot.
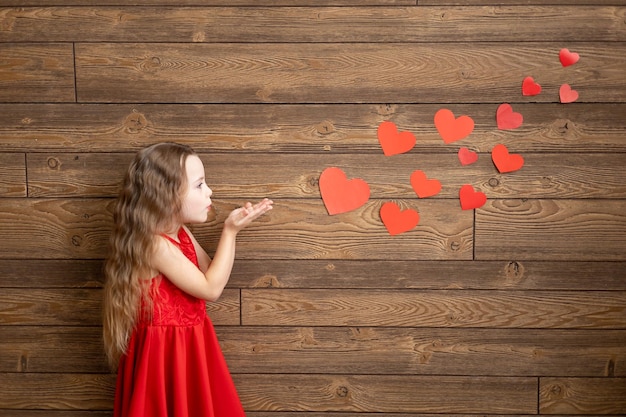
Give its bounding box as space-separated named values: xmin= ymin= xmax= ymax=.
xmin=234 ymin=375 xmax=537 ymax=414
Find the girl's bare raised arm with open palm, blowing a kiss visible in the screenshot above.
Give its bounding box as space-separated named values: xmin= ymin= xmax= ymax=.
xmin=152 ymin=199 xmax=273 ymax=301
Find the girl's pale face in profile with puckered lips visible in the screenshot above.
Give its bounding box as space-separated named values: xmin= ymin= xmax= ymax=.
xmin=181 ymin=155 xmax=213 ymax=223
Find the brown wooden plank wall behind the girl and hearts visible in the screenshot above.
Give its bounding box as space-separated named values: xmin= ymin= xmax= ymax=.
xmin=0 ymin=0 xmax=626 ymax=417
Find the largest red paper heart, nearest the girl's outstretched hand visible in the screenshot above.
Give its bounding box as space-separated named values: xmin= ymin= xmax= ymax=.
xmin=319 ymin=167 xmax=370 ymax=215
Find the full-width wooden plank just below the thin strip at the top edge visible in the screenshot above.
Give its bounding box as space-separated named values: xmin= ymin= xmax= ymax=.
xmin=0 ymin=5 xmax=626 ymax=43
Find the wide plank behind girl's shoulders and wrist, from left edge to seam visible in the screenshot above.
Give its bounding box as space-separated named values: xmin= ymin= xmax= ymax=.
xmin=0 ymin=199 xmax=473 ymax=260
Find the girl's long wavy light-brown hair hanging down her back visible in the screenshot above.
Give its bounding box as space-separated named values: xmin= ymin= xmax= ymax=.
xmin=103 ymin=143 xmax=195 ymax=369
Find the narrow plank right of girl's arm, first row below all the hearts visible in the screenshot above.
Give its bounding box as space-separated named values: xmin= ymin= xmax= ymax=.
xmin=229 ymin=259 xmax=626 ymax=291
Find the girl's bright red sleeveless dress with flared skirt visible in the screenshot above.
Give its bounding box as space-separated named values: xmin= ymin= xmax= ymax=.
xmin=113 ymin=228 xmax=245 ymax=417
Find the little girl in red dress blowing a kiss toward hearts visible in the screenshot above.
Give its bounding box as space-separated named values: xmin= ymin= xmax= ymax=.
xmin=103 ymin=143 xmax=273 ymax=417
